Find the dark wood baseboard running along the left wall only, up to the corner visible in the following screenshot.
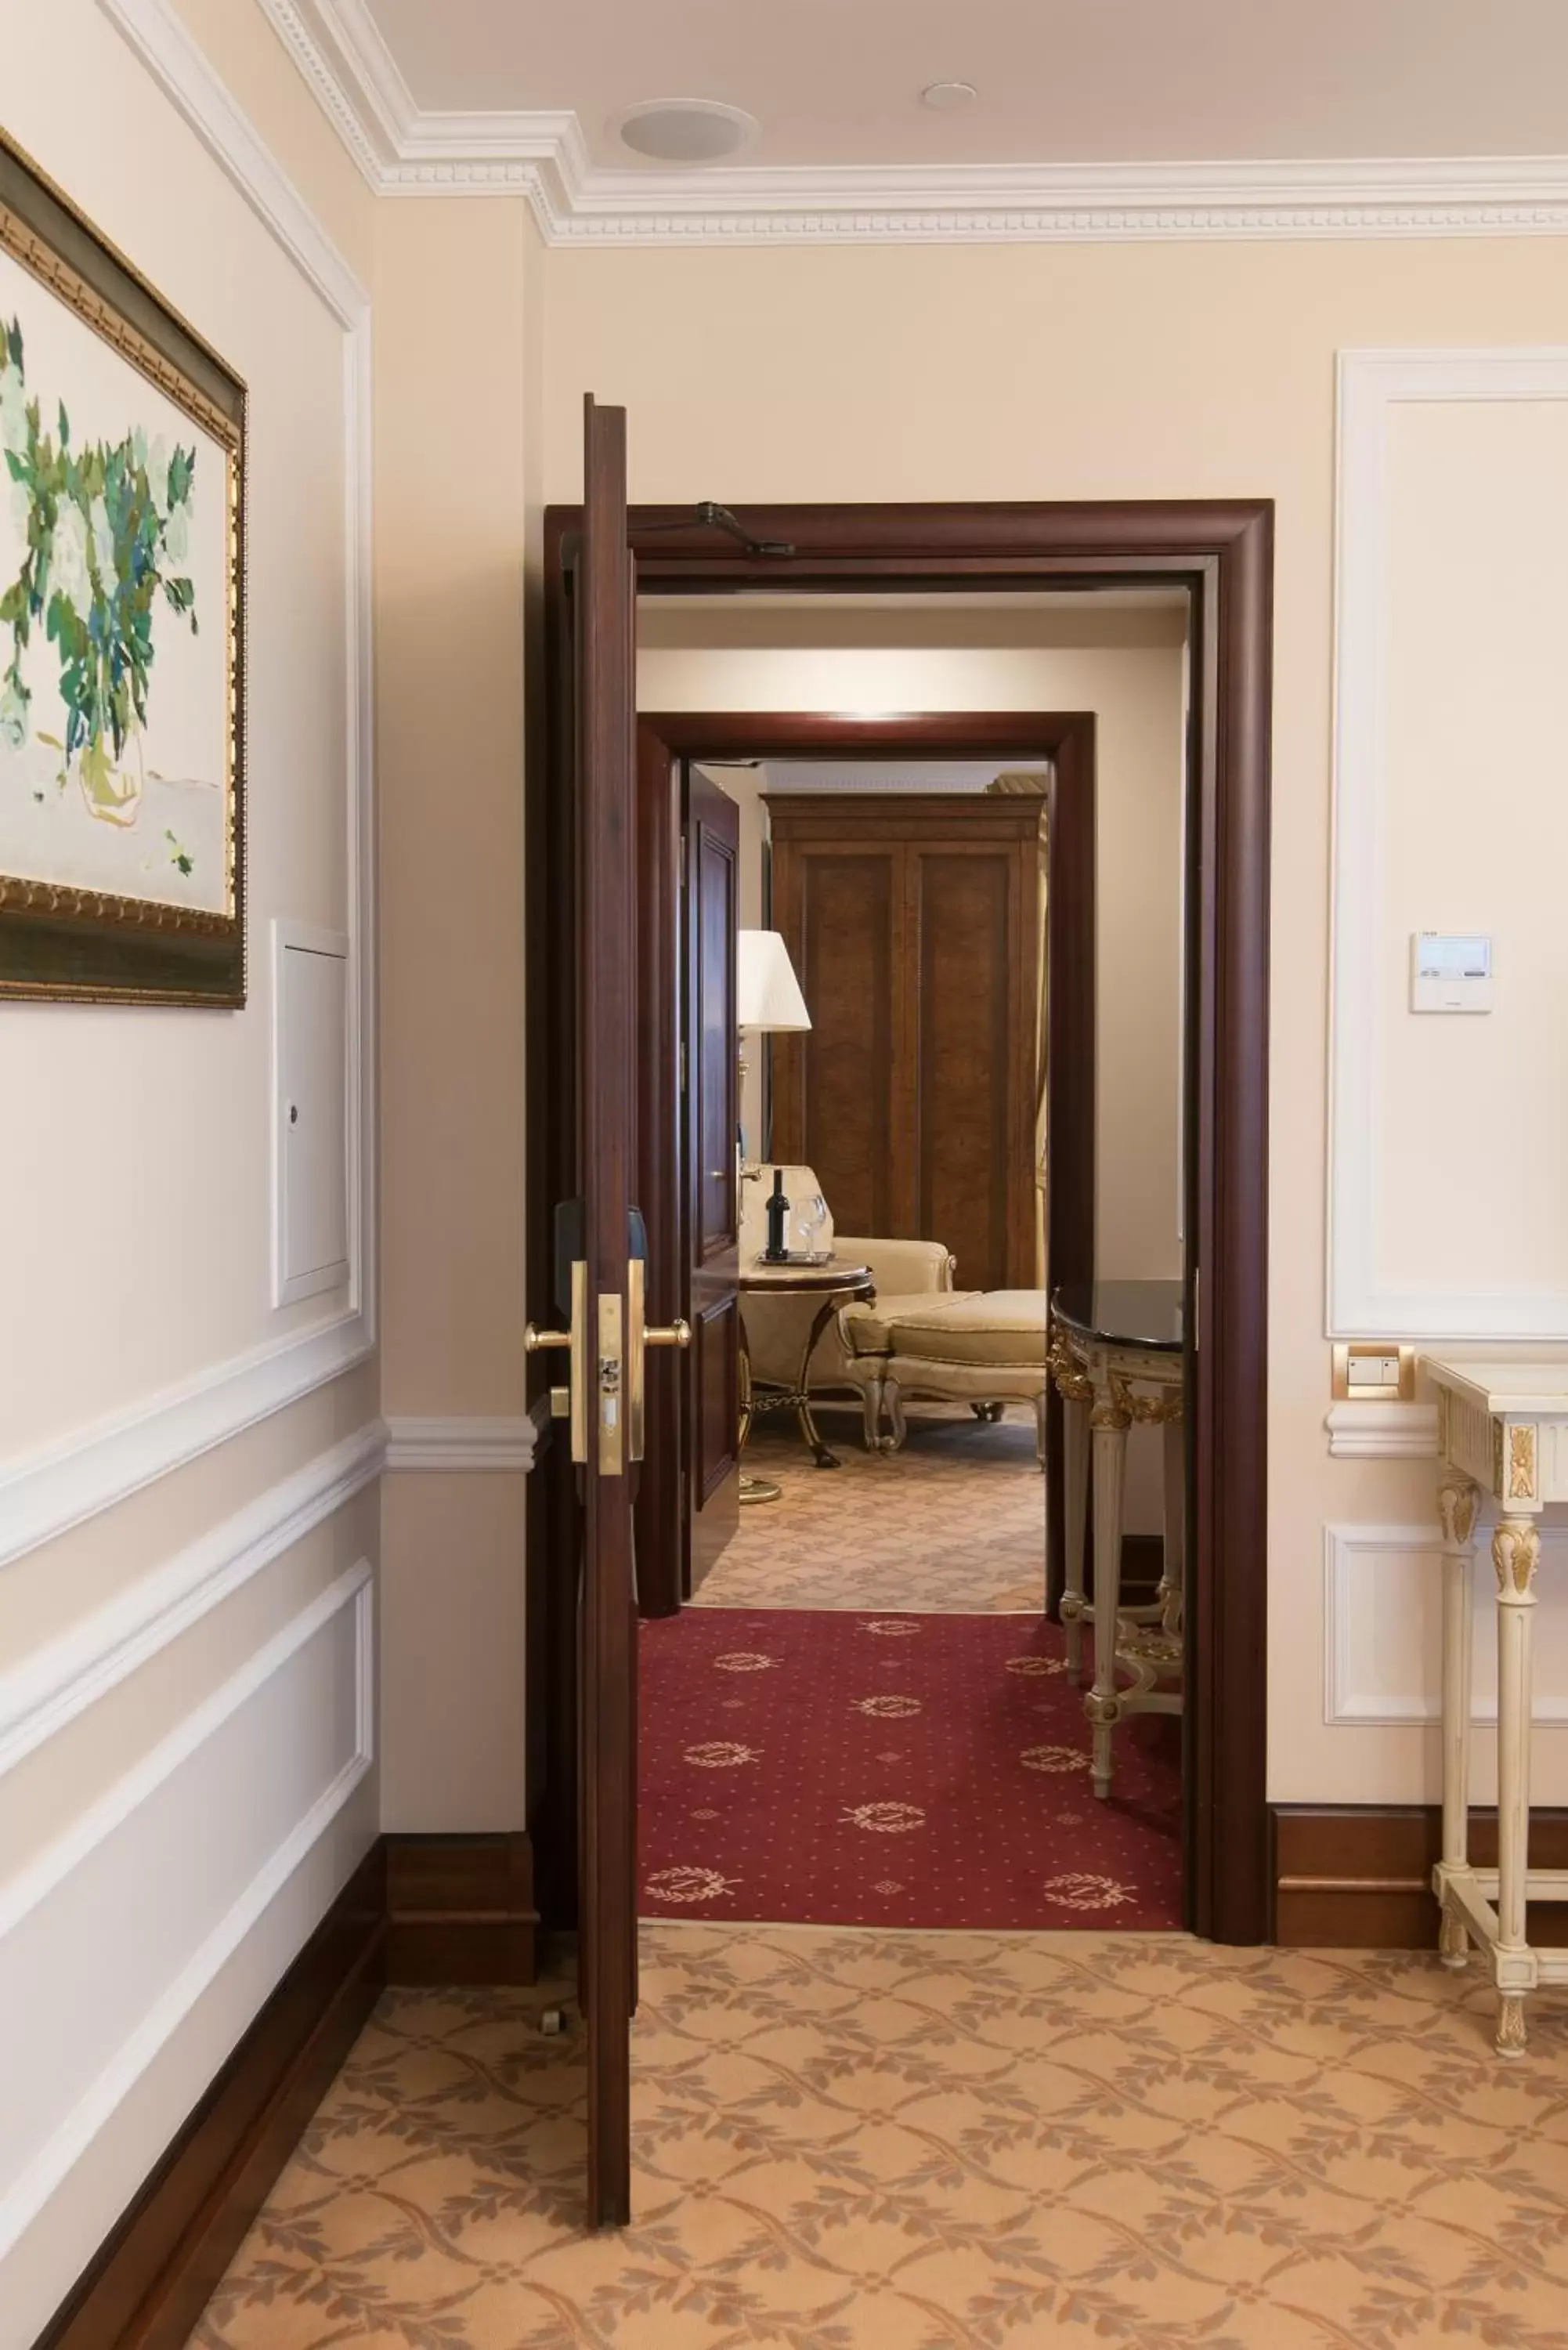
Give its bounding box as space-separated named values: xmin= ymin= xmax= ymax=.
xmin=35 ymin=1847 xmax=385 ymax=2350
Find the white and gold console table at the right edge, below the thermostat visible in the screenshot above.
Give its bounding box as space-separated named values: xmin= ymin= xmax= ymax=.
xmin=1422 ymin=1356 xmax=1568 ymax=2056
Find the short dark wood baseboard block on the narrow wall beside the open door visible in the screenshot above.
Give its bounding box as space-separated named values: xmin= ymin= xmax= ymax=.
xmin=383 ymin=1835 xmax=538 ymax=1983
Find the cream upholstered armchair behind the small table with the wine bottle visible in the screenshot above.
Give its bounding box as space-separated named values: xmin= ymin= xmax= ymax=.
xmin=740 ymin=1166 xmax=952 ymax=1452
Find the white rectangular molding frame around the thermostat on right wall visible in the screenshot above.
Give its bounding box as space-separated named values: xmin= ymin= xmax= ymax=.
xmin=1326 ymin=348 xmax=1568 ymax=1342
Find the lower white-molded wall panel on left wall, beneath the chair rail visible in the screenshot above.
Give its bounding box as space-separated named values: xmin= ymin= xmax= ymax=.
xmin=0 ymin=1560 xmax=376 ymax=2350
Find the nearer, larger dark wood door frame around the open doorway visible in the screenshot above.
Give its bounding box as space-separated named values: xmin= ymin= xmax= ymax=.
xmin=540 ymin=498 xmax=1274 ymax=1943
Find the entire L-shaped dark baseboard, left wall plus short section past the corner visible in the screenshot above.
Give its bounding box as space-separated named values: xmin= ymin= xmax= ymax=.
xmin=33 ymin=1835 xmax=538 ymax=2350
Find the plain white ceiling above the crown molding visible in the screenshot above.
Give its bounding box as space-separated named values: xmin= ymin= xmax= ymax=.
xmin=369 ymin=0 xmax=1568 ymax=176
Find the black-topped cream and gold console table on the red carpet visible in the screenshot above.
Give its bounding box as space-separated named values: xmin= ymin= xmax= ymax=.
xmin=1049 ymin=1281 xmax=1187 ymax=1800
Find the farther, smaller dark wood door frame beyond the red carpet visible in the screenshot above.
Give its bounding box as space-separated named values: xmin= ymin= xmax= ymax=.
xmin=637 ymin=710 xmax=1096 ymax=1614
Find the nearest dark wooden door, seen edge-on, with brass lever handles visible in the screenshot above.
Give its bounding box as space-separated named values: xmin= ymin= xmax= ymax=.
xmin=526 ymin=400 xmax=686 ymax=2228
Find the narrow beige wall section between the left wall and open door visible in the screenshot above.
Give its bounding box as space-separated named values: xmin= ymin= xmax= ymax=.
xmin=376 ymin=200 xmax=538 ymax=1831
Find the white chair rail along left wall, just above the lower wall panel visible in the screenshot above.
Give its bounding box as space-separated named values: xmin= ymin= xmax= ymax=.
xmin=0 ymin=1419 xmax=385 ymax=1779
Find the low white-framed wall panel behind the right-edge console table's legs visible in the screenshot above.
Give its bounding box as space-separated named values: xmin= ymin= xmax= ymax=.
xmin=1324 ymin=1520 xmax=1568 ymax=1730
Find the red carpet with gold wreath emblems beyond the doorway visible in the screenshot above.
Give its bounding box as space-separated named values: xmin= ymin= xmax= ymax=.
xmin=639 ymin=1607 xmax=1180 ymax=1927
